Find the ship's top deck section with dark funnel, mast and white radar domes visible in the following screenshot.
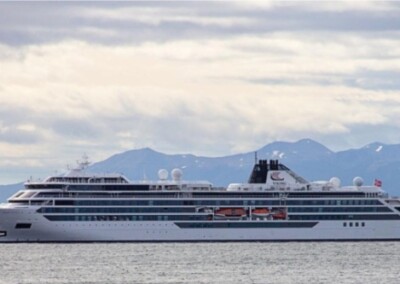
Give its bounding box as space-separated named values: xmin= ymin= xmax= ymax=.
xmin=16 ymin=160 xmax=386 ymax=197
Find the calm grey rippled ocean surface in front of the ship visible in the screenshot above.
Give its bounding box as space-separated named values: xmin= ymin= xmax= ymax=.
xmin=0 ymin=242 xmax=400 ymax=284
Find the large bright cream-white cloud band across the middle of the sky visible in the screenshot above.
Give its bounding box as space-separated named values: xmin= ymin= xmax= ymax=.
xmin=0 ymin=33 xmax=399 ymax=160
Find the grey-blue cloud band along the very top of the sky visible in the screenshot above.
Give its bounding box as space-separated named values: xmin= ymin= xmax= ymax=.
xmin=0 ymin=2 xmax=400 ymax=45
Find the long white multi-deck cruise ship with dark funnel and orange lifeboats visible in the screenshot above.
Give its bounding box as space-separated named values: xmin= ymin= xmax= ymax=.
xmin=0 ymin=160 xmax=400 ymax=242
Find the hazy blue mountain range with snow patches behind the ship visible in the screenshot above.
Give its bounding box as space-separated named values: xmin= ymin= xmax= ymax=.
xmin=0 ymin=139 xmax=400 ymax=201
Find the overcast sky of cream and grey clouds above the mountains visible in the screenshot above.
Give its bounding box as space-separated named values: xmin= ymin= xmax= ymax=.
xmin=0 ymin=1 xmax=400 ymax=183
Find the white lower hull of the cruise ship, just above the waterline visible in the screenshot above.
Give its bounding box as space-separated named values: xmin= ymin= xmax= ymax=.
xmin=0 ymin=209 xmax=400 ymax=242
